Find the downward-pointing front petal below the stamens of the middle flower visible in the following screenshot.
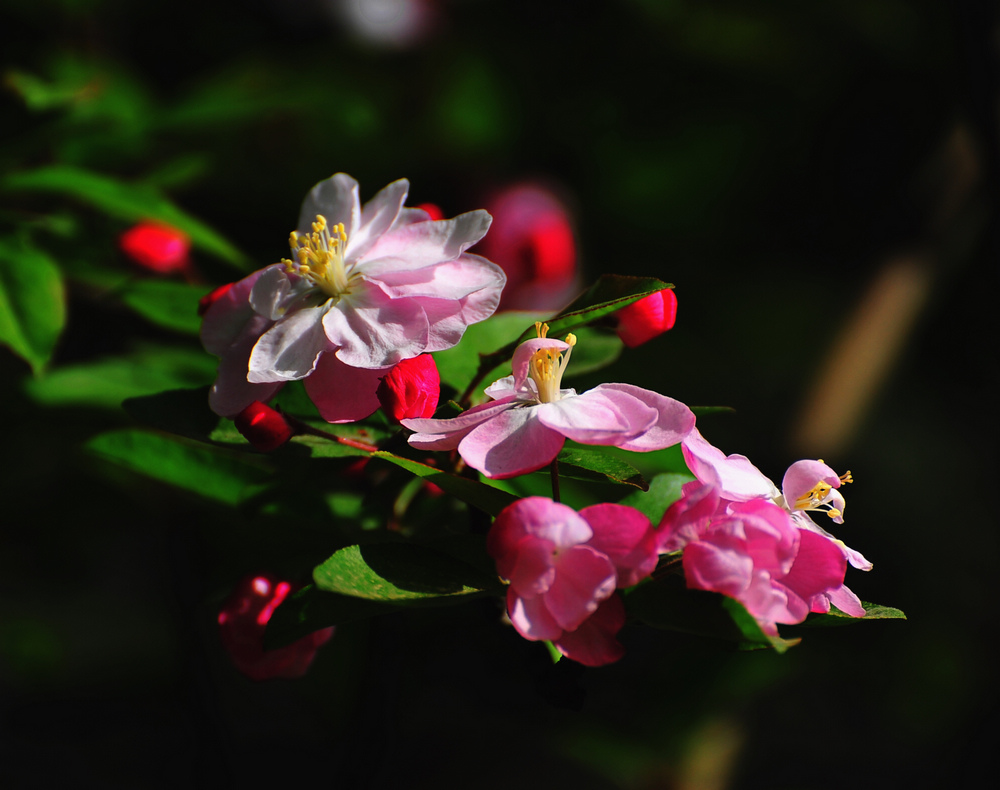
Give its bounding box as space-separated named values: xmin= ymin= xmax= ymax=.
xmin=458 ymin=406 xmax=566 ymax=479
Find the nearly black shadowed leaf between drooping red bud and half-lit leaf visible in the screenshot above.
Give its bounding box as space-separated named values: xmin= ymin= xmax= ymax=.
xmin=264 ymin=584 xmax=398 ymax=650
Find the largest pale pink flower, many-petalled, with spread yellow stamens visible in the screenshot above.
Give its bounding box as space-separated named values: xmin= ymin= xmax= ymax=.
xmin=202 ymin=173 xmax=505 ymax=422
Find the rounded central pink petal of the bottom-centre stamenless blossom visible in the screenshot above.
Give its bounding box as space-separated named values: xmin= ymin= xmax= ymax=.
xmin=543 ymin=546 xmax=617 ymax=631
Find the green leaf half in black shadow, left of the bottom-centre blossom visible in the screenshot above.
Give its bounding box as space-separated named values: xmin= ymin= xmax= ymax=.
xmin=313 ymin=543 xmax=498 ymax=605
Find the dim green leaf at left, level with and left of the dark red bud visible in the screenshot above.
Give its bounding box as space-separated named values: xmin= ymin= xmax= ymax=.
xmin=85 ymin=430 xmax=270 ymax=505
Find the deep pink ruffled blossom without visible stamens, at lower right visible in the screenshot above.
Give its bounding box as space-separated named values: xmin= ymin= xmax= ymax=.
xmin=660 ymin=486 xmax=847 ymax=635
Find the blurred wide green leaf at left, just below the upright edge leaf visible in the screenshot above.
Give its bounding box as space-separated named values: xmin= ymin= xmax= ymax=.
xmin=25 ymin=346 xmax=218 ymax=409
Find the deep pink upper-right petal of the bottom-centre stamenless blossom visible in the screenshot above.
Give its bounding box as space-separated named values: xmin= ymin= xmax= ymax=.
xmin=580 ymin=504 xmax=659 ymax=587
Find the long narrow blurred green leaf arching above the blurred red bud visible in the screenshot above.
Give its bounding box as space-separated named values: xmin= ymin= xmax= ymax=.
xmin=0 ymin=165 xmax=248 ymax=271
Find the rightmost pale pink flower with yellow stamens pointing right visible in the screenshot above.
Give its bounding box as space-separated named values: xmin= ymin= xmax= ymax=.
xmin=681 ymin=429 xmax=872 ymax=617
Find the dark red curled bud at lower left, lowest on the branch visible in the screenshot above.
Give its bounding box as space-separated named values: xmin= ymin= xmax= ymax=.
xmin=219 ymin=574 xmax=333 ymax=680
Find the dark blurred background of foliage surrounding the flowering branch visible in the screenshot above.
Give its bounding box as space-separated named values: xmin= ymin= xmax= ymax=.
xmin=0 ymin=0 xmax=1000 ymax=790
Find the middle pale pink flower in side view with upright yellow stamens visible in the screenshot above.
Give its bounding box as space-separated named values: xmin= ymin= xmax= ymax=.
xmin=402 ymin=324 xmax=694 ymax=478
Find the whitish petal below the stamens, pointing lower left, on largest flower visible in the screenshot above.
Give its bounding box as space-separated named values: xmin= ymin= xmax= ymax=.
xmin=247 ymin=306 xmax=332 ymax=384
